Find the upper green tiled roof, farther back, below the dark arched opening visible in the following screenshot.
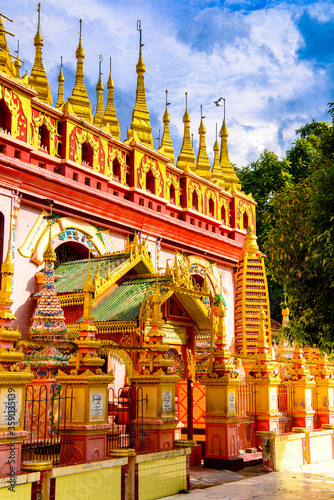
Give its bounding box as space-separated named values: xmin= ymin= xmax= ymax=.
xmin=55 ymin=253 xmax=130 ymax=293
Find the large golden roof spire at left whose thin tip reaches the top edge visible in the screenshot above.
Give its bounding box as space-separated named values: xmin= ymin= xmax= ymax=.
xmin=28 ymin=2 xmax=52 ymax=106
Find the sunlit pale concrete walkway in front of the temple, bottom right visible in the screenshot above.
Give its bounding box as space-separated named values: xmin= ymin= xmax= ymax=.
xmin=163 ymin=460 xmax=334 ymax=500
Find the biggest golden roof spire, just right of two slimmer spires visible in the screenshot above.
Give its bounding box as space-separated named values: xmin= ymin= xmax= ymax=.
xmin=128 ymin=19 xmax=153 ymax=148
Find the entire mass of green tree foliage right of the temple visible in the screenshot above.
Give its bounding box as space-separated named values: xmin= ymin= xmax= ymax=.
xmin=237 ymin=113 xmax=334 ymax=334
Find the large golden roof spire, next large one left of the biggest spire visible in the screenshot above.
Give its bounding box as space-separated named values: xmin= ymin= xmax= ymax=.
xmin=67 ymin=19 xmax=93 ymax=123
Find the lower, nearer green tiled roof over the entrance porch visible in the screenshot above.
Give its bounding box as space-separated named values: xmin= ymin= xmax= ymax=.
xmin=87 ymin=278 xmax=170 ymax=322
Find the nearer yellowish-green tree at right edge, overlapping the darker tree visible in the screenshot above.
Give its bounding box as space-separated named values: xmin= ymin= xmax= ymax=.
xmin=264 ymin=116 xmax=334 ymax=353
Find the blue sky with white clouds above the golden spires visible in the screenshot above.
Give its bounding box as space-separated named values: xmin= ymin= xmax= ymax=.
xmin=1 ymin=0 xmax=334 ymax=167
